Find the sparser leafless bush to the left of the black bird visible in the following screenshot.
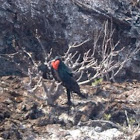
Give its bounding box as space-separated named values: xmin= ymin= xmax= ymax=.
xmin=0 ymin=37 xmax=64 ymax=105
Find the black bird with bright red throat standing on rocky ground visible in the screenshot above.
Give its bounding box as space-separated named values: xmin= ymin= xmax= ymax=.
xmin=51 ymin=57 xmax=86 ymax=105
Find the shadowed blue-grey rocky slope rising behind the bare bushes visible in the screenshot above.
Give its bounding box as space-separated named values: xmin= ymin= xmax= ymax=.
xmin=0 ymin=0 xmax=140 ymax=79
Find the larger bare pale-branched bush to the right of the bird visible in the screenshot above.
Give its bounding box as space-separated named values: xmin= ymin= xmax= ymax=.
xmin=63 ymin=21 xmax=140 ymax=84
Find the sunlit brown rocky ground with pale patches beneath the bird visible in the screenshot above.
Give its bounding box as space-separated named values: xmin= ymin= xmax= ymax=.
xmin=0 ymin=76 xmax=140 ymax=140
